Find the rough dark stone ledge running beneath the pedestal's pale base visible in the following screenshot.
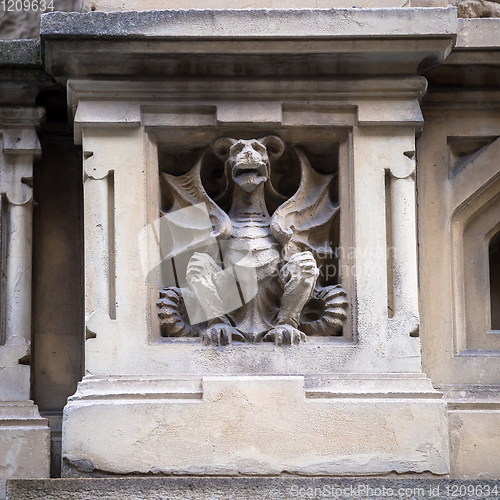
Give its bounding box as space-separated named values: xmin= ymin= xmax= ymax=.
xmin=7 ymin=477 xmax=500 ymax=500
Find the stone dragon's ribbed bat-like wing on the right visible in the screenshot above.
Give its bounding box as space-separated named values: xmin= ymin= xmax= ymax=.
xmin=271 ymin=149 xmax=340 ymax=259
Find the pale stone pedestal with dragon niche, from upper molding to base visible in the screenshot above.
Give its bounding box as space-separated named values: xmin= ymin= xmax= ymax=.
xmin=62 ymin=78 xmax=449 ymax=476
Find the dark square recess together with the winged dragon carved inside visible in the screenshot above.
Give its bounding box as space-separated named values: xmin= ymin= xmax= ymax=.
xmin=157 ymin=138 xmax=348 ymax=345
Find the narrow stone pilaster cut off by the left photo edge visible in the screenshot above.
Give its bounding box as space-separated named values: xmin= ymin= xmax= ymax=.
xmin=0 ymin=42 xmax=50 ymax=498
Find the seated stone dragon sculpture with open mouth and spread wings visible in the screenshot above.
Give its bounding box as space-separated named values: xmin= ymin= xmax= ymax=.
xmin=158 ymin=136 xmax=348 ymax=345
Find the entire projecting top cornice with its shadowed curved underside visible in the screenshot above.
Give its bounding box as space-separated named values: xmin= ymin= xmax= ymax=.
xmin=41 ymin=8 xmax=457 ymax=82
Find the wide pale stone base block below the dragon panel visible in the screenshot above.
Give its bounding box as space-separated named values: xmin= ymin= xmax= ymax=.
xmin=62 ymin=374 xmax=449 ymax=477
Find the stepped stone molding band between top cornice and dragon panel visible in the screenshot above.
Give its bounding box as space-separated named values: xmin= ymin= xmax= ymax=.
xmin=68 ymin=77 xmax=427 ymax=144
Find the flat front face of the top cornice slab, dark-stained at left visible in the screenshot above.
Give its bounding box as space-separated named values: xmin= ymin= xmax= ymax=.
xmin=41 ymin=7 xmax=456 ymax=38
